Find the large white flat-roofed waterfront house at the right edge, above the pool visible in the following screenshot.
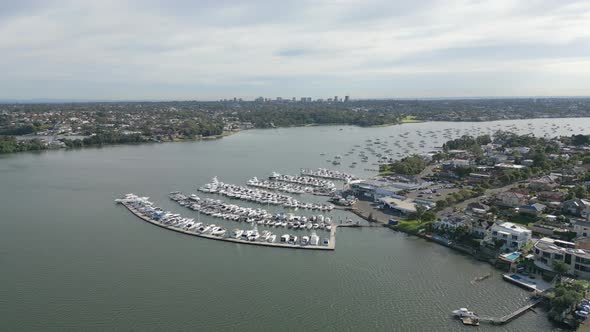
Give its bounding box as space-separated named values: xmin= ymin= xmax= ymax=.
xmin=534 ymin=237 xmax=590 ymax=279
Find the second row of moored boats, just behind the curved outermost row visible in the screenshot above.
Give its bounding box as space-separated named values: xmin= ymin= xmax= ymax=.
xmin=169 ymin=191 xmax=332 ymax=231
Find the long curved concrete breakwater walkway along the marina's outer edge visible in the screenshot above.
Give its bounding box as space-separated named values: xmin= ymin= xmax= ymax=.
xmin=121 ymin=202 xmax=338 ymax=250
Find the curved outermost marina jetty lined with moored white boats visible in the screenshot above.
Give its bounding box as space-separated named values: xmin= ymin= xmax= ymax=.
xmin=115 ymin=194 xmax=337 ymax=250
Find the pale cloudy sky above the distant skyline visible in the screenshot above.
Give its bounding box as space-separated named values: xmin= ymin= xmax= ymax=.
xmin=0 ymin=0 xmax=590 ymax=100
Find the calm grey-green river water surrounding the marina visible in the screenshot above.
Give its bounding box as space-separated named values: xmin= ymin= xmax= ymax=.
xmin=0 ymin=119 xmax=590 ymax=331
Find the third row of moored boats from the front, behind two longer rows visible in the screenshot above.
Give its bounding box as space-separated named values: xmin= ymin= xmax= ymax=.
xmin=199 ymin=177 xmax=334 ymax=211
